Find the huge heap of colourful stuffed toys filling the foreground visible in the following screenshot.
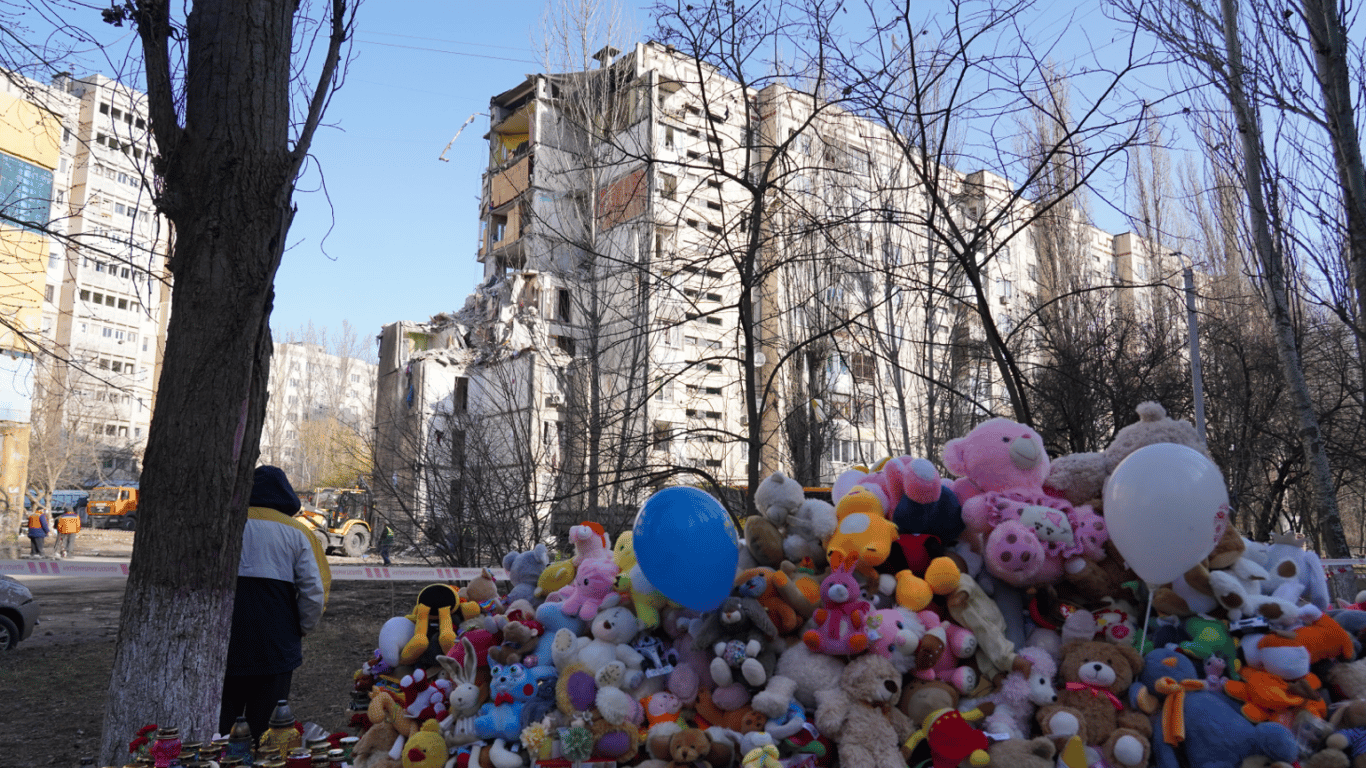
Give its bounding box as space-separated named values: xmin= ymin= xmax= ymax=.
xmin=344 ymin=403 xmax=1366 ymax=768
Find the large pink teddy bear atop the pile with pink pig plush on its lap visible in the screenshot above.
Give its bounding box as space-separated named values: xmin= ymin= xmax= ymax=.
xmin=944 ymin=418 xmax=1109 ymax=588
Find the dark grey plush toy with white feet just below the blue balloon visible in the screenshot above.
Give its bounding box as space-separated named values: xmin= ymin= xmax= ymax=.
xmin=693 ymin=594 xmax=777 ymax=687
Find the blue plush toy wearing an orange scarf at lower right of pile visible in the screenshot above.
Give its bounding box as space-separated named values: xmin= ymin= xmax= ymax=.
xmin=1130 ymin=648 xmax=1299 ymax=768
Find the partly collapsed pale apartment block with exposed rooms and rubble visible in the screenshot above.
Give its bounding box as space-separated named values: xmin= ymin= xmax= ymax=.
xmin=376 ymin=42 xmax=1149 ymax=546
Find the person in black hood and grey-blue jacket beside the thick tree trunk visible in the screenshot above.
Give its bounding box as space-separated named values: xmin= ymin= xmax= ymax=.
xmin=219 ymin=466 xmax=332 ymax=739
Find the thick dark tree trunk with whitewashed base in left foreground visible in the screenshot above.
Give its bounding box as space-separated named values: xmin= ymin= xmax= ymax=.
xmin=100 ymin=0 xmax=346 ymax=764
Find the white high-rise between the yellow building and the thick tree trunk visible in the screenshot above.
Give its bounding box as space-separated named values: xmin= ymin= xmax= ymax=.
xmin=38 ymin=75 xmax=171 ymax=481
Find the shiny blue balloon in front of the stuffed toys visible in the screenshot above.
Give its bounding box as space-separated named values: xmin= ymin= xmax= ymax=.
xmin=631 ymin=486 xmax=739 ymax=611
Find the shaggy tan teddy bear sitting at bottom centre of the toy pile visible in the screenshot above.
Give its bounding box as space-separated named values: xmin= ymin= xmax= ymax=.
xmin=816 ymin=653 xmax=915 ymax=768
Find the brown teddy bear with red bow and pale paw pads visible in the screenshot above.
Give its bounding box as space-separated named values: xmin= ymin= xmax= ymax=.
xmin=1035 ymin=640 xmax=1153 ymax=768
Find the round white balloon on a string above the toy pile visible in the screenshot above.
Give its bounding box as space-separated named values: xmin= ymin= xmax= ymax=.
xmin=1105 ymin=443 xmax=1228 ymax=585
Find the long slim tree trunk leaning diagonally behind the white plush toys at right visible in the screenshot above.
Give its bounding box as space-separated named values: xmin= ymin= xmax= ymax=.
xmin=1220 ymin=0 xmax=1351 ymax=558
